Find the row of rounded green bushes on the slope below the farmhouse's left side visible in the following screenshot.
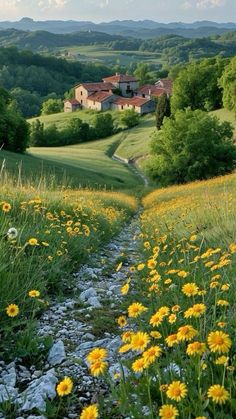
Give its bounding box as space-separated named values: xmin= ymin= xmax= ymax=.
xmin=30 ymin=113 xmax=117 ymax=147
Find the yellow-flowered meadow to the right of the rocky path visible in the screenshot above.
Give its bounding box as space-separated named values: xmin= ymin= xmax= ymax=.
xmin=108 ymin=174 xmax=236 ymax=419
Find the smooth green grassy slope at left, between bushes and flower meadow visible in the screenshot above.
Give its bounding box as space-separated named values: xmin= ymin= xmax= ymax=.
xmin=0 ymin=131 xmax=140 ymax=189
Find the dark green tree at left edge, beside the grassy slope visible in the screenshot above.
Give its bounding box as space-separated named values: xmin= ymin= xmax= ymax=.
xmin=0 ymin=88 xmax=29 ymax=153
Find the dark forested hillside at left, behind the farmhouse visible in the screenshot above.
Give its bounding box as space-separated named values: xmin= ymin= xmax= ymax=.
xmin=0 ymin=47 xmax=112 ymax=117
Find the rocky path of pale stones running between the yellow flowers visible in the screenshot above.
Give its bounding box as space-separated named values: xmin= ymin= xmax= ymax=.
xmin=0 ymin=216 xmax=139 ymax=419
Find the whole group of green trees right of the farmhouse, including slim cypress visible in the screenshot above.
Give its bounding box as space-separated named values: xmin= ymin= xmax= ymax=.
xmin=148 ymin=58 xmax=236 ymax=185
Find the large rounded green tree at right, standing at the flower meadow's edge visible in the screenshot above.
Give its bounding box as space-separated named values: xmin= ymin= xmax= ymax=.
xmin=149 ymin=109 xmax=236 ymax=184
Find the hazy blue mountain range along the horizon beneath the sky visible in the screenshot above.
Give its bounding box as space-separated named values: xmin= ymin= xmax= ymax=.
xmin=0 ymin=17 xmax=236 ymax=38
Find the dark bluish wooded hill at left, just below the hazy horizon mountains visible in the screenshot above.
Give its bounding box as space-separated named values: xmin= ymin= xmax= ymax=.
xmin=0 ymin=29 xmax=124 ymax=51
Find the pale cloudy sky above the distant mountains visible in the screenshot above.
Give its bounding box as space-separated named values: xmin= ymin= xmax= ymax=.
xmin=0 ymin=0 xmax=236 ymax=23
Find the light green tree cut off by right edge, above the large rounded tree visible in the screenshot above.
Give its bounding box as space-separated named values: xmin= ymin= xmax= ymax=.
xmin=220 ymin=57 xmax=236 ymax=114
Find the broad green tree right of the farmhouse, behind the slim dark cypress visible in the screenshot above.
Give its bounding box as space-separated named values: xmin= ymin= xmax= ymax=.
xmin=171 ymin=58 xmax=227 ymax=113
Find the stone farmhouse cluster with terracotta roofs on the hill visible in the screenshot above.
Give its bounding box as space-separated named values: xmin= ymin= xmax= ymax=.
xmin=64 ymin=73 xmax=172 ymax=115
